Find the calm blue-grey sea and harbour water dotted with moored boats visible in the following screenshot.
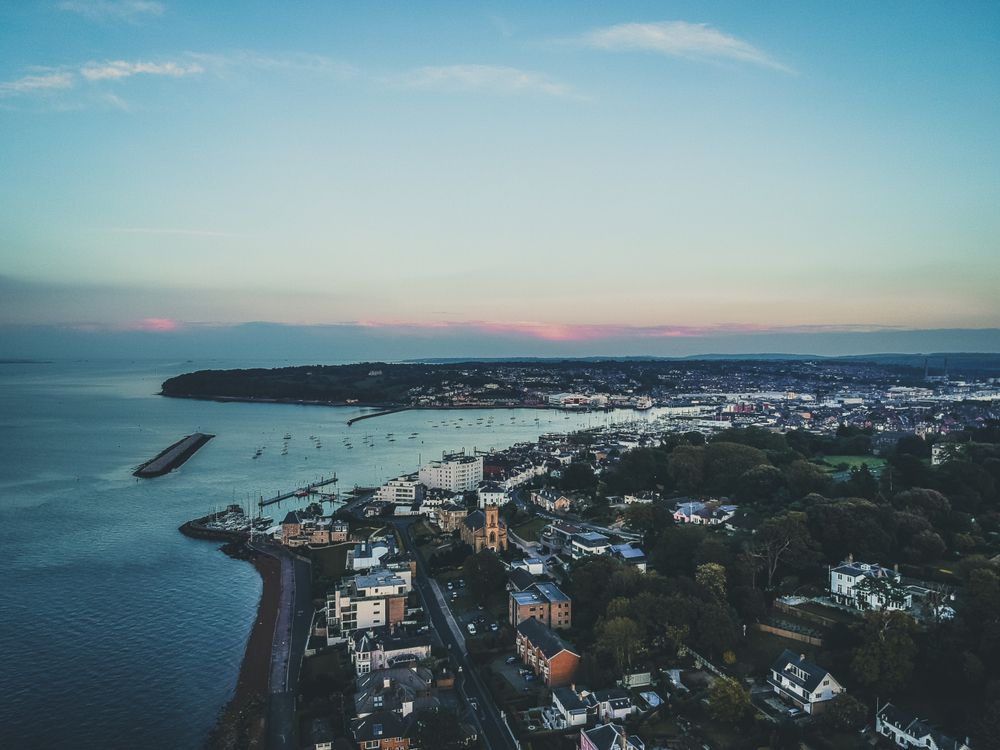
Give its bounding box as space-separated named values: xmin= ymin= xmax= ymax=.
xmin=0 ymin=360 xmax=653 ymax=750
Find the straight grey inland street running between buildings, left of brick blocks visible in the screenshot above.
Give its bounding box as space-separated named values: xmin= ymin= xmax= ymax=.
xmin=392 ymin=518 xmax=517 ymax=750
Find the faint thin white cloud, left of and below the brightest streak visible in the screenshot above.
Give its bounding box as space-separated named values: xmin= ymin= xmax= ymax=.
xmin=399 ymin=65 xmax=578 ymax=97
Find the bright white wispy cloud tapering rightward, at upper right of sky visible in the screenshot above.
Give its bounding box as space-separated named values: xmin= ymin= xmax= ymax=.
xmin=577 ymin=21 xmax=793 ymax=73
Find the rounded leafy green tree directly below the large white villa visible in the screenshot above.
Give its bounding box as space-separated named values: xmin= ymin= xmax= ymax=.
xmin=851 ymin=610 xmax=917 ymax=695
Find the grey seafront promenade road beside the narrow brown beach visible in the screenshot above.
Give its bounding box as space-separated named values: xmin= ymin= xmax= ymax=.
xmin=250 ymin=541 xmax=312 ymax=750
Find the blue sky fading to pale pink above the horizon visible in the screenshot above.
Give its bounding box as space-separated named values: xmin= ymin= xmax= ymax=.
xmin=0 ymin=0 xmax=1000 ymax=357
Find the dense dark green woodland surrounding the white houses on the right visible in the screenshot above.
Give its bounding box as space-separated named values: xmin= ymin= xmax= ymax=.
xmin=516 ymin=428 xmax=1000 ymax=749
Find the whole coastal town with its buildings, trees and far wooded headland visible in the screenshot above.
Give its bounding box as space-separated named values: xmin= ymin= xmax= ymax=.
xmin=189 ymin=359 xmax=1000 ymax=750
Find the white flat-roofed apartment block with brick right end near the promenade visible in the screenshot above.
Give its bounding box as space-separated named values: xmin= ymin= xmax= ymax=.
xmin=326 ymin=570 xmax=409 ymax=643
